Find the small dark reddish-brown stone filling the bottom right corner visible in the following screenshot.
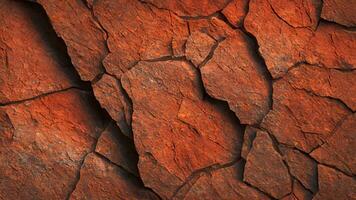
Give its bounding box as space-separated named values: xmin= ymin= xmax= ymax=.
xmin=313 ymin=165 xmax=356 ymax=200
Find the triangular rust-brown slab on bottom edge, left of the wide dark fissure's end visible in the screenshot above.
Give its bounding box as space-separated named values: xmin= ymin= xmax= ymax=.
xmin=70 ymin=153 xmax=159 ymax=200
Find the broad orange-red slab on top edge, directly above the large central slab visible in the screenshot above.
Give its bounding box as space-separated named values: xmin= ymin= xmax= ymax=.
xmin=94 ymin=0 xmax=189 ymax=78
